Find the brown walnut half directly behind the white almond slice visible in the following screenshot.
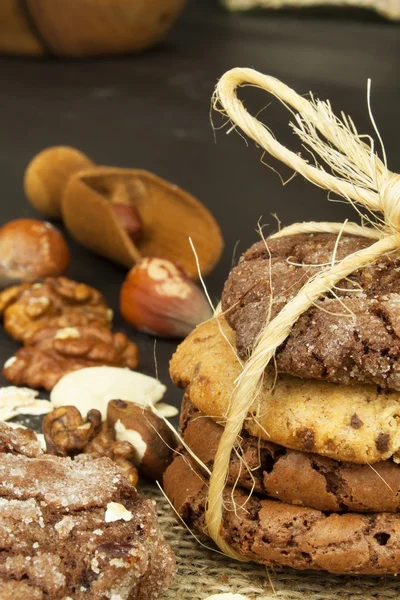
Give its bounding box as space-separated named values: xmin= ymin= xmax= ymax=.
xmin=3 ymin=325 xmax=139 ymax=391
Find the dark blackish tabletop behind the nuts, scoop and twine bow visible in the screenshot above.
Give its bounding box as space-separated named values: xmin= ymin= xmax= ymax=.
xmin=0 ymin=0 xmax=400 ymax=412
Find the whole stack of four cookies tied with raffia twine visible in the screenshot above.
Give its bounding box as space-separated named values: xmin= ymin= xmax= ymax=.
xmin=164 ymin=234 xmax=400 ymax=574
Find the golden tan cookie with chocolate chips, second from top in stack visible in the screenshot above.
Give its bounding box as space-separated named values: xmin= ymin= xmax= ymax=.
xmin=170 ymin=318 xmax=400 ymax=463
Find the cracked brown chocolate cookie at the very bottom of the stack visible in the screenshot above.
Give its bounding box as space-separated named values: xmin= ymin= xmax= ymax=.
xmin=164 ymin=456 xmax=400 ymax=575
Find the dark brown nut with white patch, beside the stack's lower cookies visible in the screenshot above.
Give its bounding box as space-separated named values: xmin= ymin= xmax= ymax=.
xmin=107 ymin=400 xmax=177 ymax=480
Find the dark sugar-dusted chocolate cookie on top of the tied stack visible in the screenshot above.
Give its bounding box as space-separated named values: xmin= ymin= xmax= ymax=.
xmin=222 ymin=233 xmax=400 ymax=390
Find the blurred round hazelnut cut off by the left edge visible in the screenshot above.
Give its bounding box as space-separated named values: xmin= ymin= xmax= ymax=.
xmin=0 ymin=219 xmax=70 ymax=281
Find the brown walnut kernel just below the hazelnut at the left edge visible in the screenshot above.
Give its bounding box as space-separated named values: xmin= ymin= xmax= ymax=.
xmin=0 ymin=277 xmax=112 ymax=342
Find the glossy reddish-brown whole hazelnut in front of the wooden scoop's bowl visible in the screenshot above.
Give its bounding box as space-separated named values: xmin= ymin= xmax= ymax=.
xmin=120 ymin=258 xmax=212 ymax=337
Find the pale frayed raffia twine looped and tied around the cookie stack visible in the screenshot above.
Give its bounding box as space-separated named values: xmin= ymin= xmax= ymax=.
xmin=206 ymin=68 xmax=400 ymax=560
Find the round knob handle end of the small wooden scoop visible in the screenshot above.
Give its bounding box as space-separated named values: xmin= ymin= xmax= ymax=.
xmin=24 ymin=146 xmax=93 ymax=219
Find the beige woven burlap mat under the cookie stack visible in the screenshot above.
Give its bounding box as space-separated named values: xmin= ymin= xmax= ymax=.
xmin=140 ymin=487 xmax=400 ymax=600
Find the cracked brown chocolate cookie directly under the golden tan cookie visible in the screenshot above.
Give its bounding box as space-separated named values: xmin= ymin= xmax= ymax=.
xmin=181 ymin=397 xmax=400 ymax=512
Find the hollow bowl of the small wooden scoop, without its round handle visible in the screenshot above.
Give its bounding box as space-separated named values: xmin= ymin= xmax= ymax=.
xmin=62 ymin=167 xmax=223 ymax=278
